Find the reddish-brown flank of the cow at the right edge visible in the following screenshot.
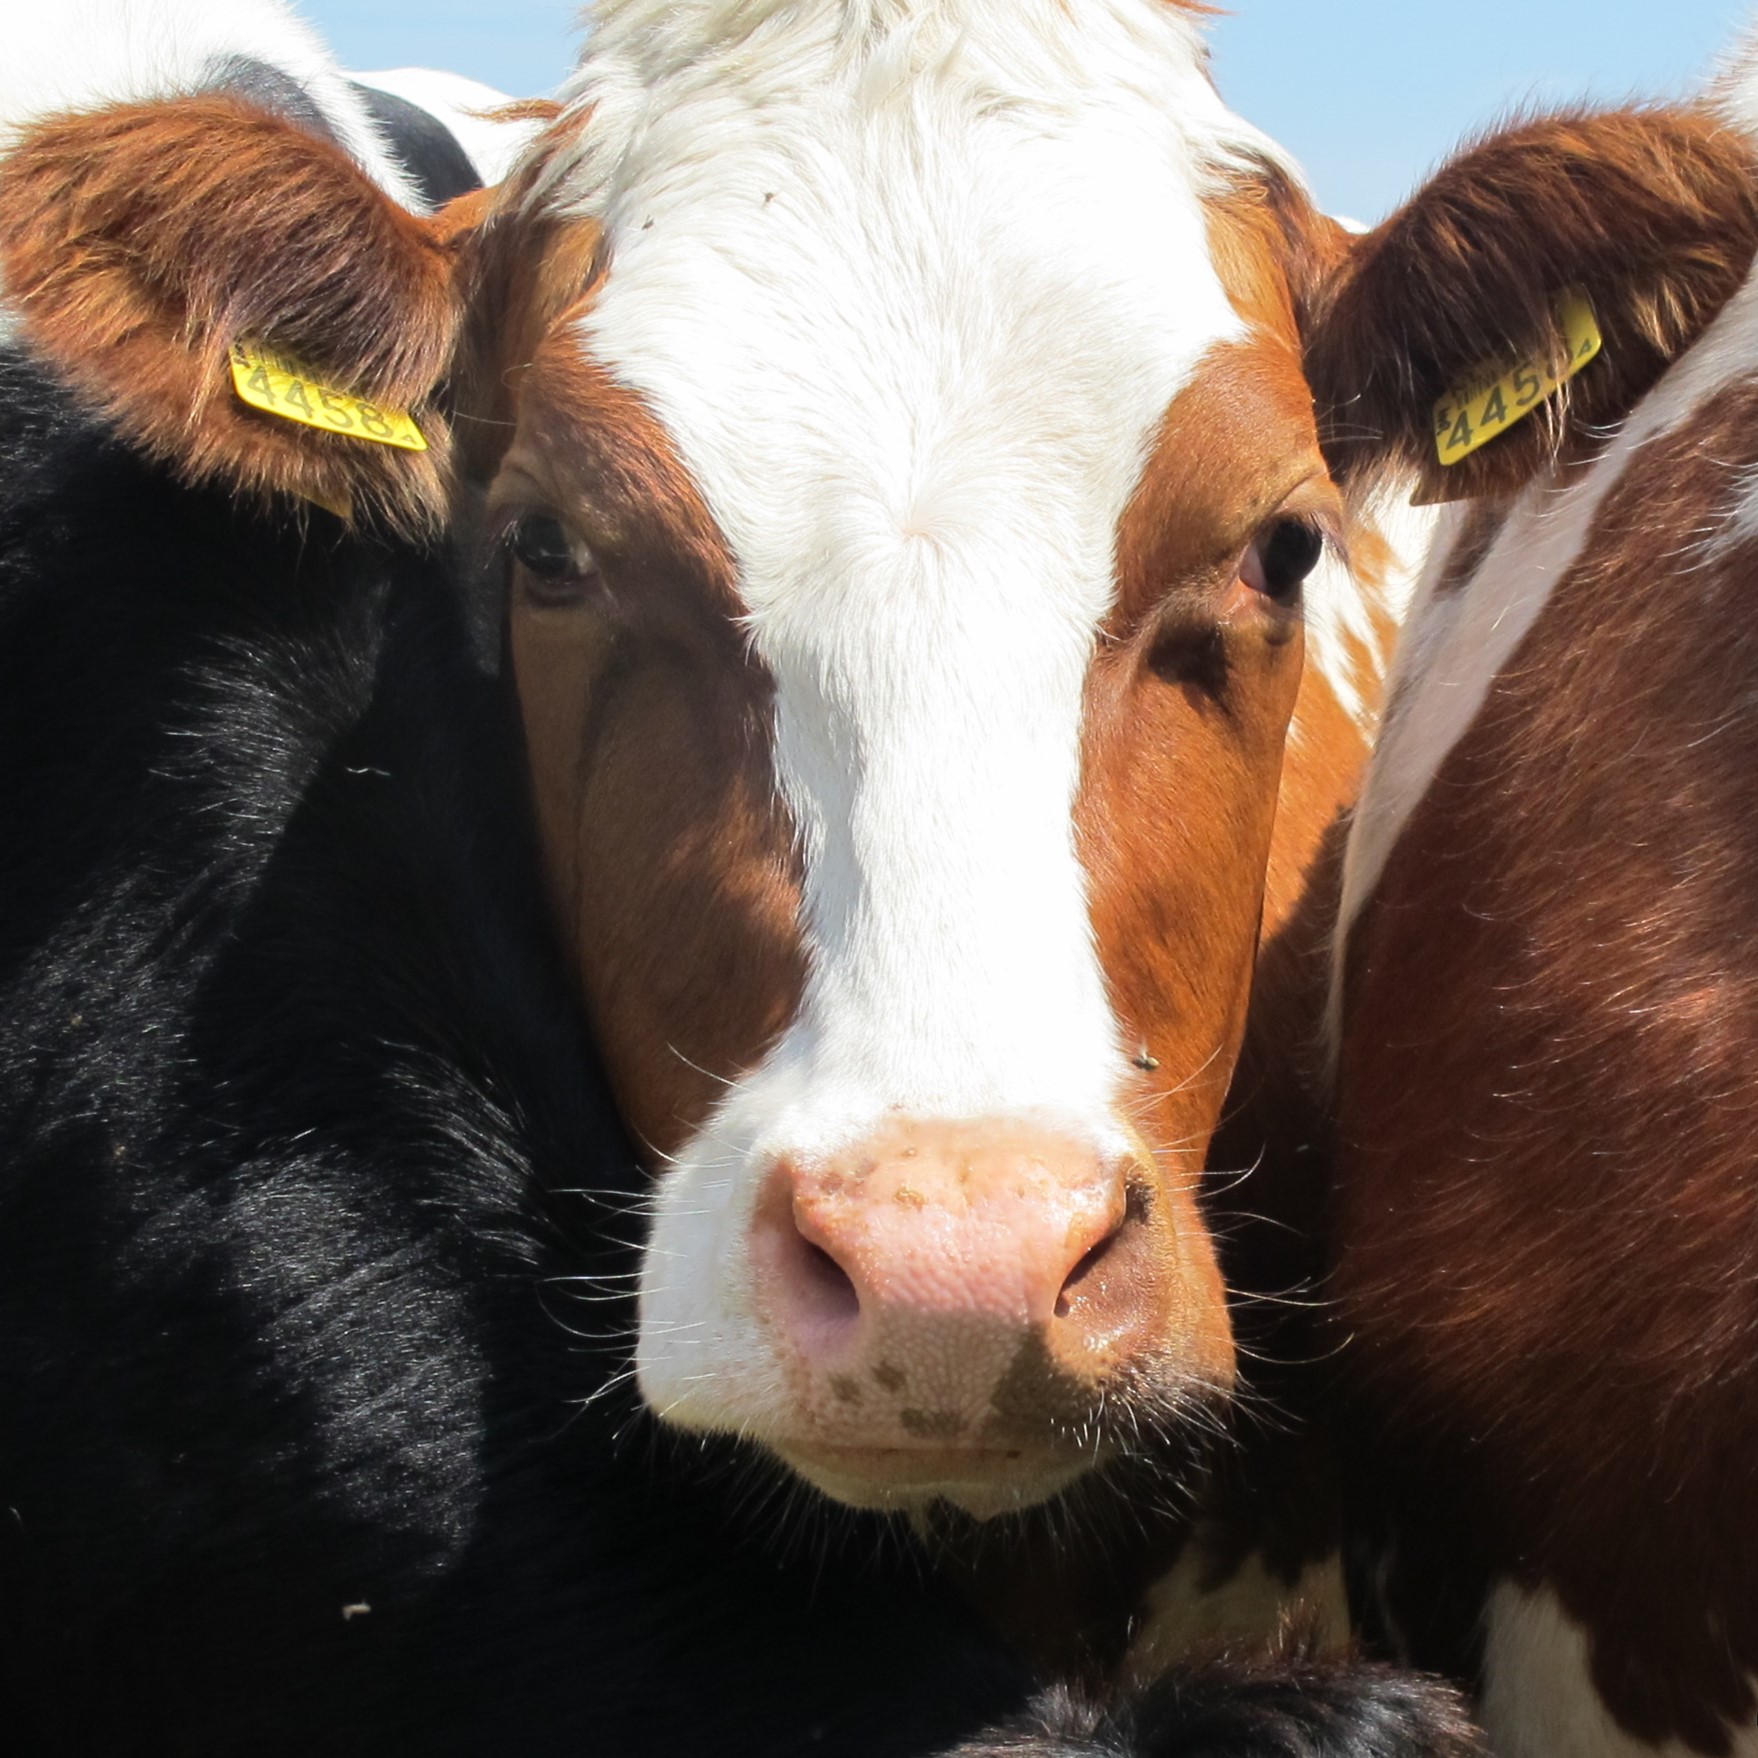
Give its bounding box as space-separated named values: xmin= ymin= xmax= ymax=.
xmin=1334 ymin=353 xmax=1758 ymax=1753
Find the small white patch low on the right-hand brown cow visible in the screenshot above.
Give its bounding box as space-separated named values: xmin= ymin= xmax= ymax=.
xmin=1478 ymin=1582 xmax=1758 ymax=1758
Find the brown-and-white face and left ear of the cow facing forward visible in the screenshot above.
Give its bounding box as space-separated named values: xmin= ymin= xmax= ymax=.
xmin=0 ymin=0 xmax=1420 ymax=1624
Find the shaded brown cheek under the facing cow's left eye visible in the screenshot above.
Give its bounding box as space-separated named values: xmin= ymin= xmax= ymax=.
xmin=512 ymin=610 xmax=803 ymax=1157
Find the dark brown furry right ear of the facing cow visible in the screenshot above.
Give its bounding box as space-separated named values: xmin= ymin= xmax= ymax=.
xmin=1308 ymin=111 xmax=1758 ymax=499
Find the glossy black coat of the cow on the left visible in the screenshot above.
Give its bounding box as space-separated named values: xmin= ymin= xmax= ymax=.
xmin=0 ymin=355 xmax=1483 ymax=1758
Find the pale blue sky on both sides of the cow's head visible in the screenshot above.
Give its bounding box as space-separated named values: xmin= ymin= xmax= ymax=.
xmin=302 ymin=0 xmax=1753 ymax=220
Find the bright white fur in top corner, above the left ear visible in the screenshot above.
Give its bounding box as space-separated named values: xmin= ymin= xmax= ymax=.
xmin=0 ymin=0 xmax=420 ymax=207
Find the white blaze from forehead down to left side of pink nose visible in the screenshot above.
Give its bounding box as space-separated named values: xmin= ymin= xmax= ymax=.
xmin=550 ymin=0 xmax=1293 ymax=1433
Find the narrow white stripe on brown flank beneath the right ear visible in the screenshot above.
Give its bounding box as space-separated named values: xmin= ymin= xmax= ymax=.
xmin=1331 ymin=267 xmax=1758 ymax=1044
